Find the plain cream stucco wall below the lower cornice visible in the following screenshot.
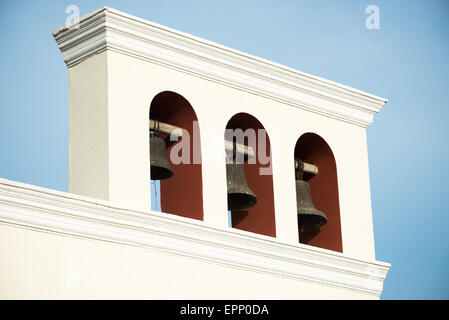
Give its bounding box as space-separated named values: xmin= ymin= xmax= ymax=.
xmin=0 ymin=225 xmax=374 ymax=299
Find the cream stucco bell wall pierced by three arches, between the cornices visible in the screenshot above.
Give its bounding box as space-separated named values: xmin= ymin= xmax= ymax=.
xmin=69 ymin=51 xmax=375 ymax=259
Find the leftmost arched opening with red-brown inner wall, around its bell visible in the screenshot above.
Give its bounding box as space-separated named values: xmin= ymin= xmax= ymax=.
xmin=150 ymin=91 xmax=203 ymax=220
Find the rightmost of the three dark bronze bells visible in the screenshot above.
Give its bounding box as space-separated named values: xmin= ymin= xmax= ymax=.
xmin=296 ymin=161 xmax=327 ymax=231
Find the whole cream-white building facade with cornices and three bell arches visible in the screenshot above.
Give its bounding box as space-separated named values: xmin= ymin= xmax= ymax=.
xmin=0 ymin=8 xmax=390 ymax=299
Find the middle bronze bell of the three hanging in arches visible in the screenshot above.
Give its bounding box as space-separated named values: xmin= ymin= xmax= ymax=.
xmin=226 ymin=142 xmax=257 ymax=210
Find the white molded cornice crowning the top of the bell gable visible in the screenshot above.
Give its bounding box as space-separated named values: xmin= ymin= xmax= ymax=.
xmin=53 ymin=7 xmax=387 ymax=127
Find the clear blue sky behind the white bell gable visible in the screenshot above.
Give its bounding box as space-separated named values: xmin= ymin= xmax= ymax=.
xmin=0 ymin=0 xmax=449 ymax=299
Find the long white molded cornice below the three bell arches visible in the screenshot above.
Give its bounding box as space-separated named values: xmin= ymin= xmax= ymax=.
xmin=0 ymin=179 xmax=390 ymax=297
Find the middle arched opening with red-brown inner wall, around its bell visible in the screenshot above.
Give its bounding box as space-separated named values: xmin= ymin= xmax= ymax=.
xmin=225 ymin=113 xmax=276 ymax=237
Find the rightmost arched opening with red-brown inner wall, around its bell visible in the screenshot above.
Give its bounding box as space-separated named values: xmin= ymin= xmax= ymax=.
xmin=295 ymin=133 xmax=343 ymax=252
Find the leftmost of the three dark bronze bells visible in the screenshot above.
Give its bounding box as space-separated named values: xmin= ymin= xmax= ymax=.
xmin=150 ymin=132 xmax=173 ymax=180
